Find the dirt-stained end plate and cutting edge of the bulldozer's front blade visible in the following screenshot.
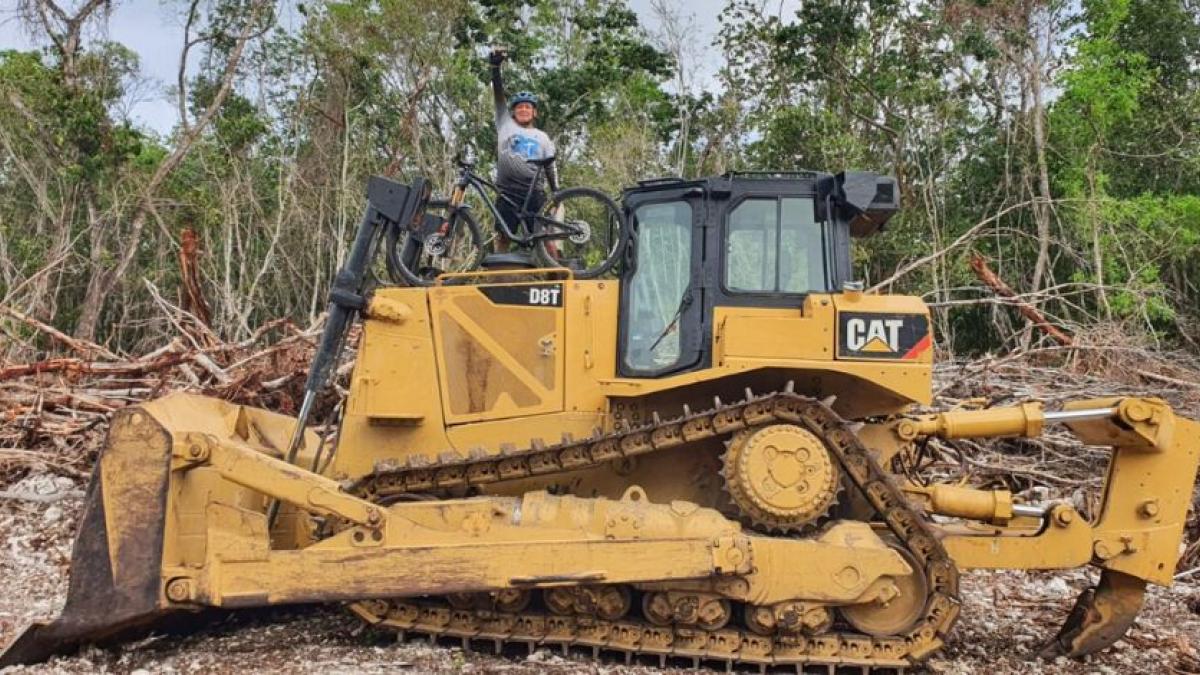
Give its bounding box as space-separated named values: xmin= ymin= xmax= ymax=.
xmin=0 ymin=410 xmax=170 ymax=668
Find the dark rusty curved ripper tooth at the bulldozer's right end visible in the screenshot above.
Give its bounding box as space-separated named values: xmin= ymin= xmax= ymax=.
xmin=1042 ymin=569 xmax=1146 ymax=658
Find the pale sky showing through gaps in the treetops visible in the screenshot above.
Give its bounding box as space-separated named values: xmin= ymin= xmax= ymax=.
xmin=0 ymin=0 xmax=799 ymax=133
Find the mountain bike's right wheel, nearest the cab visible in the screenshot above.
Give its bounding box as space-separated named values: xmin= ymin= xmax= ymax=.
xmin=534 ymin=187 xmax=629 ymax=279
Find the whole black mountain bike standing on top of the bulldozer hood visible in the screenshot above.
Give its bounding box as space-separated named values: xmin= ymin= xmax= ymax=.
xmin=388 ymin=151 xmax=629 ymax=286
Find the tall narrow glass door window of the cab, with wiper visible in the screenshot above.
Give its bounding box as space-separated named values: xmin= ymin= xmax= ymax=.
xmin=624 ymin=202 xmax=692 ymax=372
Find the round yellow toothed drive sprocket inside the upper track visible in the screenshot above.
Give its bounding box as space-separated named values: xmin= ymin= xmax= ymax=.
xmin=722 ymin=424 xmax=841 ymax=532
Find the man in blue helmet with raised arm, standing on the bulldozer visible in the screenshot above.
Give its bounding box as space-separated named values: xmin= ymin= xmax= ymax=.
xmin=488 ymin=48 xmax=558 ymax=247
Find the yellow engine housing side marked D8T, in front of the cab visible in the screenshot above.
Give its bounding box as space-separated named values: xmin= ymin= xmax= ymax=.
xmin=333 ymin=281 xmax=619 ymax=478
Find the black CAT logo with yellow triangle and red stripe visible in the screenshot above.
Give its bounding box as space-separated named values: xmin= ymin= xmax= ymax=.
xmin=838 ymin=312 xmax=932 ymax=359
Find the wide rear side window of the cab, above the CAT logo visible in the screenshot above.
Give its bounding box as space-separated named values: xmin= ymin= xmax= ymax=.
xmin=725 ymin=197 xmax=828 ymax=293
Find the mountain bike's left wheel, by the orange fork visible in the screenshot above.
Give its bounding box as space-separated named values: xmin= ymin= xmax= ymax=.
xmin=388 ymin=200 xmax=484 ymax=286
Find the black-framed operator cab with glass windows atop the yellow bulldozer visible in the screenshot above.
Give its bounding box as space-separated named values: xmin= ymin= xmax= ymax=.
xmin=618 ymin=172 xmax=899 ymax=377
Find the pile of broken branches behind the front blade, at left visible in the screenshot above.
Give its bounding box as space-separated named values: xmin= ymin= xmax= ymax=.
xmin=0 ymin=307 xmax=349 ymax=489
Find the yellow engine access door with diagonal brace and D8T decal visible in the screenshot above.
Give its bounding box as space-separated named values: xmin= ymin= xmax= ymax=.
xmin=428 ymin=281 xmax=566 ymax=424
